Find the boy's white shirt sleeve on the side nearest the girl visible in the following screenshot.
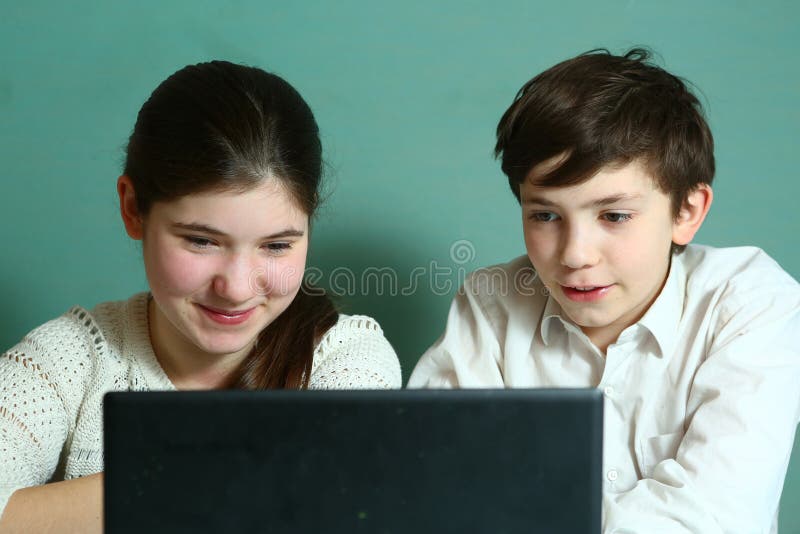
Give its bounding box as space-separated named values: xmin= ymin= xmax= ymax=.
xmin=408 ymin=277 xmax=504 ymax=389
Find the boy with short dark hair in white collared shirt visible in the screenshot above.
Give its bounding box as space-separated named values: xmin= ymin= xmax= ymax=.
xmin=409 ymin=49 xmax=800 ymax=534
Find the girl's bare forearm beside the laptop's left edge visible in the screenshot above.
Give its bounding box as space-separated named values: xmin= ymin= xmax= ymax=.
xmin=0 ymin=473 xmax=103 ymax=534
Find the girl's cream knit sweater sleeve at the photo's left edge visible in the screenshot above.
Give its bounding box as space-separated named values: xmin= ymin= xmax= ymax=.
xmin=0 ymin=308 xmax=94 ymax=514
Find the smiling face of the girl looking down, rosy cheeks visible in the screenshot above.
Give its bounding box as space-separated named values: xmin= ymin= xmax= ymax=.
xmin=136 ymin=180 xmax=308 ymax=376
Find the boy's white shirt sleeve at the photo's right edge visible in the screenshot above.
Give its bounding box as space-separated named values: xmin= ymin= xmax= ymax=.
xmin=603 ymin=281 xmax=800 ymax=534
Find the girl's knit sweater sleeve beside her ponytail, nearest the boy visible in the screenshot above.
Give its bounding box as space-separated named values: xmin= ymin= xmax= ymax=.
xmin=309 ymin=315 xmax=402 ymax=389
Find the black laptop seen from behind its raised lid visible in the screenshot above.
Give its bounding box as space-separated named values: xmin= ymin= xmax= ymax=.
xmin=104 ymin=389 xmax=603 ymax=534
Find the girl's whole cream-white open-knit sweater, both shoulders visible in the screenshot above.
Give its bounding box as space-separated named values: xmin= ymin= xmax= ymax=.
xmin=0 ymin=293 xmax=401 ymax=514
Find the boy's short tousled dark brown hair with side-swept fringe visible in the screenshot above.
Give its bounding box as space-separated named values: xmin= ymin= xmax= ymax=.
xmin=495 ymin=48 xmax=714 ymax=251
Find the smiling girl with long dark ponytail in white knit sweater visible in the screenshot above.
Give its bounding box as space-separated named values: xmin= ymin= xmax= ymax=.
xmin=0 ymin=61 xmax=401 ymax=532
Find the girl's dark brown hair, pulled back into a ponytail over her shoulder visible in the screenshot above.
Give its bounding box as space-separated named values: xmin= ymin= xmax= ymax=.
xmin=124 ymin=61 xmax=338 ymax=389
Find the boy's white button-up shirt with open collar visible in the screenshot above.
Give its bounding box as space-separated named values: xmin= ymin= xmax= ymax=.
xmin=408 ymin=245 xmax=800 ymax=534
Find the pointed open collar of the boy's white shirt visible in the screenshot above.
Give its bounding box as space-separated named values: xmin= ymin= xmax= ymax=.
xmin=539 ymin=255 xmax=686 ymax=356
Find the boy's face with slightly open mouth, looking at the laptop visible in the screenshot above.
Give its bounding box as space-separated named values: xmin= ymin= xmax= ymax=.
xmin=520 ymin=160 xmax=679 ymax=351
